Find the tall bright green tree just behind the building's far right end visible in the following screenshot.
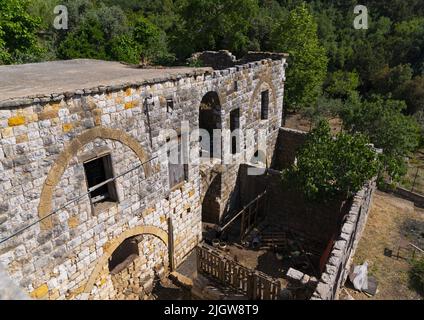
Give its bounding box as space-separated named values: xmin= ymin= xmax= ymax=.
xmin=273 ymin=3 xmax=328 ymax=110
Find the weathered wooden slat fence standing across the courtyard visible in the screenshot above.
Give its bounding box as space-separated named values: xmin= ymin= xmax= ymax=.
xmin=197 ymin=244 xmax=281 ymax=300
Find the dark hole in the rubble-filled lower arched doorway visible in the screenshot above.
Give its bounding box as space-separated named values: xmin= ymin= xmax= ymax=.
xmin=109 ymin=237 xmax=139 ymax=274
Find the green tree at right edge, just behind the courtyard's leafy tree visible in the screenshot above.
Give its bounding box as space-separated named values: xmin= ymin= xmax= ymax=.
xmin=341 ymin=95 xmax=420 ymax=182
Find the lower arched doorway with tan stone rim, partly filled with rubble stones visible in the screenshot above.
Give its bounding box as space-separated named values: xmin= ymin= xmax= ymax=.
xmin=83 ymin=226 xmax=169 ymax=300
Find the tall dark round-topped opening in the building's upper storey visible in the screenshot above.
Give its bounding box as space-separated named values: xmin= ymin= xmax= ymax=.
xmin=199 ymin=91 xmax=222 ymax=158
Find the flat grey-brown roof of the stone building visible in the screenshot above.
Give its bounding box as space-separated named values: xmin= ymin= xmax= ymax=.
xmin=0 ymin=59 xmax=212 ymax=101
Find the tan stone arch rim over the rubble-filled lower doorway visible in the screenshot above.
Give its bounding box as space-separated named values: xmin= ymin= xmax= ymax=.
xmin=82 ymin=226 xmax=169 ymax=294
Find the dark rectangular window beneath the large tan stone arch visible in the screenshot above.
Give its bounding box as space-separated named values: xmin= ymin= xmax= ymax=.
xmin=84 ymin=155 xmax=118 ymax=204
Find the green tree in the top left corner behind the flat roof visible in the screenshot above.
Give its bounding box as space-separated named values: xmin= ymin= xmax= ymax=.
xmin=0 ymin=0 xmax=42 ymax=64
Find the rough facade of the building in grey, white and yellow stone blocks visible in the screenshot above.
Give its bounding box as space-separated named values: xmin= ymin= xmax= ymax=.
xmin=0 ymin=53 xmax=286 ymax=299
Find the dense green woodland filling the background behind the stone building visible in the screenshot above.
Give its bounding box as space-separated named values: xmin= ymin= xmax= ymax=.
xmin=0 ymin=0 xmax=424 ymax=195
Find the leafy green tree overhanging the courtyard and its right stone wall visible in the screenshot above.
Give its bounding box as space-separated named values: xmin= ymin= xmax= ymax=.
xmin=282 ymin=121 xmax=379 ymax=202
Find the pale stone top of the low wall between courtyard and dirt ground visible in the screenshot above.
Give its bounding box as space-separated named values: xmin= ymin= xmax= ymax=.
xmin=312 ymin=181 xmax=376 ymax=300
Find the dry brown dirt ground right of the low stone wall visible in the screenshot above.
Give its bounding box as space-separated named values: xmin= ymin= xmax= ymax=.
xmin=341 ymin=191 xmax=424 ymax=300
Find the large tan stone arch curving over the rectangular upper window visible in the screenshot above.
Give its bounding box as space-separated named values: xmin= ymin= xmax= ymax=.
xmin=38 ymin=127 xmax=152 ymax=229
